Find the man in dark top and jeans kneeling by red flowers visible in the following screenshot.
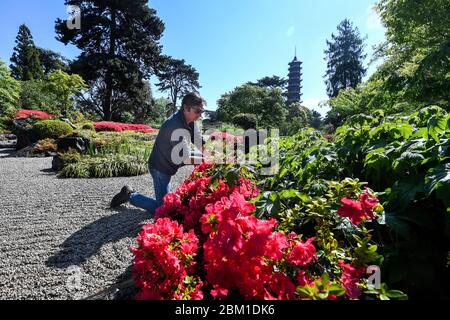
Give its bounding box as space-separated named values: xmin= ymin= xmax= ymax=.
xmin=111 ymin=93 xmax=206 ymax=214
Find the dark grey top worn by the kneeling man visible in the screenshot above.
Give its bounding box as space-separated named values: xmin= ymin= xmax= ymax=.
xmin=148 ymin=110 xmax=204 ymax=176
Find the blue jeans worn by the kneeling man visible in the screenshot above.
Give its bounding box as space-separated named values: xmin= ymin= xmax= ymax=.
xmin=130 ymin=169 xmax=172 ymax=215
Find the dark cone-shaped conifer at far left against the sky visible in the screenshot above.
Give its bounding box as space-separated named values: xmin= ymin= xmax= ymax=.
xmin=10 ymin=24 xmax=43 ymax=81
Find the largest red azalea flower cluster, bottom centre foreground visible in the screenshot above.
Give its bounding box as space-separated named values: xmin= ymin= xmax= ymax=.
xmin=201 ymin=192 xmax=316 ymax=300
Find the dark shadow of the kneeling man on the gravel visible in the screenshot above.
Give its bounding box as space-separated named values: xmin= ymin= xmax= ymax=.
xmin=46 ymin=207 xmax=149 ymax=269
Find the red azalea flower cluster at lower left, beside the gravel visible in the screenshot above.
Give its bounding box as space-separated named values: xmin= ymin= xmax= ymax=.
xmin=132 ymin=219 xmax=203 ymax=300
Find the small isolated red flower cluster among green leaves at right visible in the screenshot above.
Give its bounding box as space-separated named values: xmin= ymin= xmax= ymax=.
xmin=338 ymin=189 xmax=380 ymax=225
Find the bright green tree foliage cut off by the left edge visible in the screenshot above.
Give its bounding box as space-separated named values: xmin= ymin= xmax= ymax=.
xmin=0 ymin=60 xmax=20 ymax=116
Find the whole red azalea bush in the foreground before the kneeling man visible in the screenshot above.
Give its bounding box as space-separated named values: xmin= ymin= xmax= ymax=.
xmin=133 ymin=163 xmax=386 ymax=300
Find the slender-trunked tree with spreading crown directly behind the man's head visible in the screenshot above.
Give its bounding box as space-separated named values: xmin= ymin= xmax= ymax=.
xmin=156 ymin=57 xmax=201 ymax=113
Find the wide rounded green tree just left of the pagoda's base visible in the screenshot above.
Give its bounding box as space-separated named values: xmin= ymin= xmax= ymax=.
xmin=217 ymin=84 xmax=286 ymax=128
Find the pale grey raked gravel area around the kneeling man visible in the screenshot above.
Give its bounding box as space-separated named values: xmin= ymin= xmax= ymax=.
xmin=0 ymin=149 xmax=192 ymax=299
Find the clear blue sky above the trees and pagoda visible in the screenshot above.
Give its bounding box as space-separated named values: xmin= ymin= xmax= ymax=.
xmin=0 ymin=0 xmax=384 ymax=114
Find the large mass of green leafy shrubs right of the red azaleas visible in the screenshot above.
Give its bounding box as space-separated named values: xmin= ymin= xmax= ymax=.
xmin=246 ymin=106 xmax=450 ymax=299
